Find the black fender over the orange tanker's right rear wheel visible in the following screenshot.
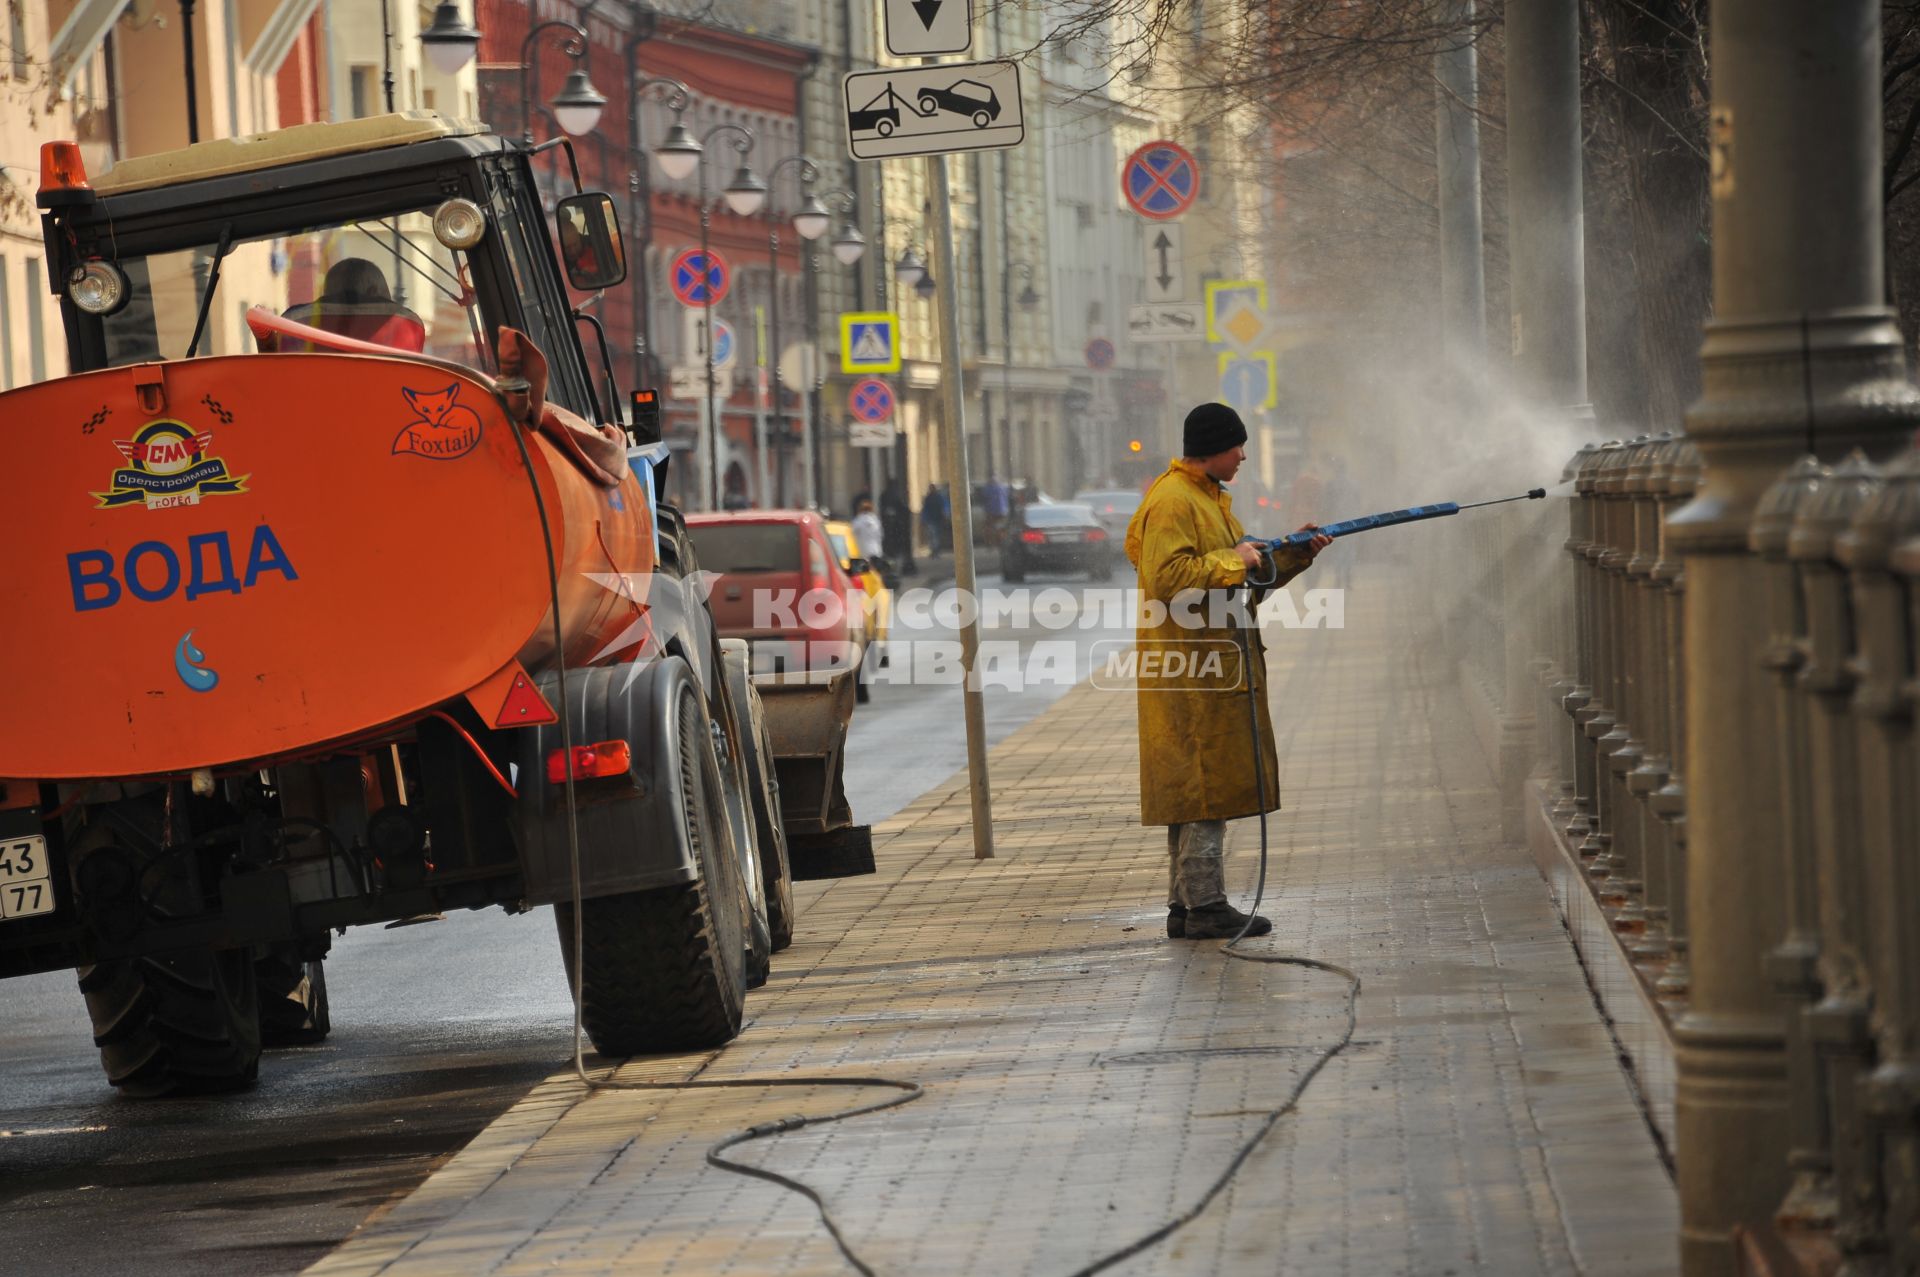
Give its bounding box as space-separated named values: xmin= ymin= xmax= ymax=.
xmin=515 ymin=657 xmax=699 ymax=904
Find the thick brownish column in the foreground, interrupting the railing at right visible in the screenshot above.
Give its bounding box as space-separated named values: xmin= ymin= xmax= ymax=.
xmin=1670 ymin=0 xmax=1914 ymax=1277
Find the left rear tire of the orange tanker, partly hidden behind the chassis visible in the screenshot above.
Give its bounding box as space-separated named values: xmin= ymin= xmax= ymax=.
xmin=73 ymin=795 xmax=259 ymax=1096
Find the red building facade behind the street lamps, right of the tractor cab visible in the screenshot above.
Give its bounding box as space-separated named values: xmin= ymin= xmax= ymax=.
xmin=474 ymin=0 xmax=816 ymax=509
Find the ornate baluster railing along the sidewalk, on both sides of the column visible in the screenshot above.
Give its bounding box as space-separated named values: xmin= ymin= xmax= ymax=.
xmin=1534 ymin=436 xmax=1920 ymax=1271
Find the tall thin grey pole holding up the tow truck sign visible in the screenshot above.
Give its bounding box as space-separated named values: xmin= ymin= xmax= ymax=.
xmin=927 ymin=156 xmax=993 ymax=860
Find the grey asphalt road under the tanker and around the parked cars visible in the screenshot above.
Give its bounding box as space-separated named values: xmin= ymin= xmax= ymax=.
xmin=0 ymin=578 xmax=1127 ymax=1277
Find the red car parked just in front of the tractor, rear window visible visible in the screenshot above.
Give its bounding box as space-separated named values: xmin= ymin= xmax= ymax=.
xmin=687 ymin=511 xmax=866 ymax=683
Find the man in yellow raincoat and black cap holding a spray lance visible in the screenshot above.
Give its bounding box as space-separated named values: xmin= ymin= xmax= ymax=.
xmin=1127 ymin=403 xmax=1331 ymax=939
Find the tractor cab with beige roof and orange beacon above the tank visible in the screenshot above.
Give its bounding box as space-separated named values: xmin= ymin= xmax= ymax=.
xmin=40 ymin=111 xmax=626 ymax=421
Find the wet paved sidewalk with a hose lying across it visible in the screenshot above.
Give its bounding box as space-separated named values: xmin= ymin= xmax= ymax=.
xmin=309 ymin=578 xmax=1676 ymax=1277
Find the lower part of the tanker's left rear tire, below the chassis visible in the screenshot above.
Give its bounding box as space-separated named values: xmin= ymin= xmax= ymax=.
xmin=79 ymin=949 xmax=259 ymax=1096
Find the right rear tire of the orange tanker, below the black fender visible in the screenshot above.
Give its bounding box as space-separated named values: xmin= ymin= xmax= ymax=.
xmin=553 ymin=682 xmax=747 ymax=1056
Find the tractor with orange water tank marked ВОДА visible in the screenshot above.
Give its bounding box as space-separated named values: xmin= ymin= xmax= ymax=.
xmin=0 ymin=111 xmax=872 ymax=1095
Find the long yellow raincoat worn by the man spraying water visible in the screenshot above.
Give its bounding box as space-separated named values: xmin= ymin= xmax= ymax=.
xmin=1127 ymin=459 xmax=1313 ymax=824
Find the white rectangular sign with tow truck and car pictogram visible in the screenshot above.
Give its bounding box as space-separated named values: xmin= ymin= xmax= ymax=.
xmin=841 ymin=61 xmax=1027 ymax=159
